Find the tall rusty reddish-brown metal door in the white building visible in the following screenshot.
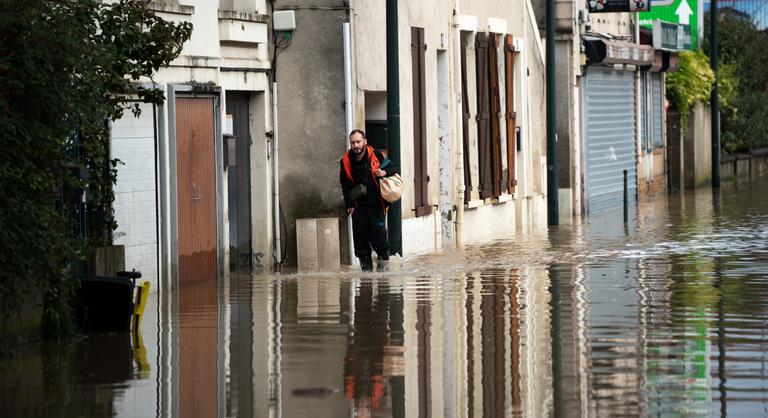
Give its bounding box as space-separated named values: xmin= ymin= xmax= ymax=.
xmin=176 ymin=97 xmax=217 ymax=284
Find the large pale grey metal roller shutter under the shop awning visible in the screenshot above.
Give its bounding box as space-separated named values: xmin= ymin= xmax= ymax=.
xmin=584 ymin=67 xmax=637 ymax=213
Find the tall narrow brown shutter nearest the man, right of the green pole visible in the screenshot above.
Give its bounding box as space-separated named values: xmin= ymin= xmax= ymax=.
xmin=411 ymin=27 xmax=432 ymax=216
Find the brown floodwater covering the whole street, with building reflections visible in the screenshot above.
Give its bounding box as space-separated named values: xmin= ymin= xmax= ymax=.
xmin=0 ymin=180 xmax=768 ymax=418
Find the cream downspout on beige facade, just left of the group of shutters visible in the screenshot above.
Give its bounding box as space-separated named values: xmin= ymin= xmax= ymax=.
xmin=453 ymin=0 xmax=467 ymax=248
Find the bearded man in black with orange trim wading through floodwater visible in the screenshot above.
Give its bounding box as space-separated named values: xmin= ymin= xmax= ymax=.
xmin=339 ymin=129 xmax=397 ymax=271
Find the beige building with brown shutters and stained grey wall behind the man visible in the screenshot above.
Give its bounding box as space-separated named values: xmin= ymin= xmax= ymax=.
xmin=275 ymin=0 xmax=546 ymax=268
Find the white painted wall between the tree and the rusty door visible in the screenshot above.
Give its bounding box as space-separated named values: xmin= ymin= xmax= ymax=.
xmin=111 ymin=104 xmax=158 ymax=292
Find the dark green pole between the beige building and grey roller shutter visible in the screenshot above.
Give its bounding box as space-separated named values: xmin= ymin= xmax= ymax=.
xmin=546 ymin=0 xmax=560 ymax=225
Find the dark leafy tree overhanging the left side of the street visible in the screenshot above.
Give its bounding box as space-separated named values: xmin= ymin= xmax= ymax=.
xmin=0 ymin=0 xmax=192 ymax=337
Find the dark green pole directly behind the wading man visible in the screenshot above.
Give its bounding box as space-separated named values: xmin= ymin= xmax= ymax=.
xmin=387 ymin=0 xmax=403 ymax=255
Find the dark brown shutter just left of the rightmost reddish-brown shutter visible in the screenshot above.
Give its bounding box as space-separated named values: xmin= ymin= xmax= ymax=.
xmin=488 ymin=33 xmax=504 ymax=197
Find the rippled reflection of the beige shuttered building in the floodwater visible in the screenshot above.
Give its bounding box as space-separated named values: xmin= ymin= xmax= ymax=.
xmin=392 ymin=269 xmax=585 ymax=417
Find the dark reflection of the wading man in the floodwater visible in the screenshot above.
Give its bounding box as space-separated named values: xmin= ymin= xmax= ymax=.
xmin=344 ymin=282 xmax=396 ymax=417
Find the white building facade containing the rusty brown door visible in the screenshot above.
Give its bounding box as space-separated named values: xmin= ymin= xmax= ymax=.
xmin=111 ymin=0 xmax=272 ymax=289
